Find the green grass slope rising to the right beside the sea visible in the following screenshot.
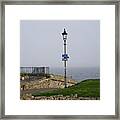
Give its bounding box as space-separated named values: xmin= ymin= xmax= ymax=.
xmin=32 ymin=79 xmax=100 ymax=97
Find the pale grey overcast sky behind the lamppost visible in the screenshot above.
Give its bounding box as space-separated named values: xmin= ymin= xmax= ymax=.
xmin=20 ymin=20 xmax=100 ymax=67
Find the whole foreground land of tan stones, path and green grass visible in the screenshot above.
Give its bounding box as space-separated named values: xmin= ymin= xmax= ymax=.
xmin=20 ymin=75 xmax=100 ymax=100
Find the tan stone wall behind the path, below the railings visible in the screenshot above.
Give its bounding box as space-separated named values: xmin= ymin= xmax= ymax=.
xmin=20 ymin=76 xmax=77 ymax=90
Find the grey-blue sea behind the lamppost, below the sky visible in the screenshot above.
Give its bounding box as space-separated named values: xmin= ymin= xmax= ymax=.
xmin=50 ymin=67 xmax=100 ymax=82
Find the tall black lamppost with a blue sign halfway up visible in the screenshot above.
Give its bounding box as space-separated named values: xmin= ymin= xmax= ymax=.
xmin=62 ymin=29 xmax=69 ymax=88
